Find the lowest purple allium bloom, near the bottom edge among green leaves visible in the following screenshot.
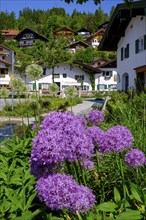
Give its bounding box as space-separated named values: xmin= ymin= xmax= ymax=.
xmin=36 ymin=174 xmax=95 ymax=212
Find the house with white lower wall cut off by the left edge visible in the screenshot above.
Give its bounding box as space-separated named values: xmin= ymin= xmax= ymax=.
xmin=0 ymin=44 xmax=15 ymax=87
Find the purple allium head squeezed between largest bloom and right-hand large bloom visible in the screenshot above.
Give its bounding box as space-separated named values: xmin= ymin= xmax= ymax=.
xmin=86 ymin=126 xmax=104 ymax=145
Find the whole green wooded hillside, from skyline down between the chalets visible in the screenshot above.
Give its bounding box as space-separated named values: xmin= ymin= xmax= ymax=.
xmin=0 ymin=6 xmax=115 ymax=74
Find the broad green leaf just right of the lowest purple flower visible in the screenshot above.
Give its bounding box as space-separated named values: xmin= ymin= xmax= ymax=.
xmin=97 ymin=201 xmax=118 ymax=212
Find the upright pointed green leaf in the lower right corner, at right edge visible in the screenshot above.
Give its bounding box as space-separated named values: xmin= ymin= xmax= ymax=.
xmin=130 ymin=183 xmax=144 ymax=203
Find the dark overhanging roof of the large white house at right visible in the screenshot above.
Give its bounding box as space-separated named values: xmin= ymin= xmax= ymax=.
xmin=98 ymin=0 xmax=146 ymax=51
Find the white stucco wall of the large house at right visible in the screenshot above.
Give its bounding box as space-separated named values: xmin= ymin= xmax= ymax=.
xmin=117 ymin=16 xmax=146 ymax=90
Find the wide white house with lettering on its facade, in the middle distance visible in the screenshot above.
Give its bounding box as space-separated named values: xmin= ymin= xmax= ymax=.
xmin=26 ymin=64 xmax=92 ymax=91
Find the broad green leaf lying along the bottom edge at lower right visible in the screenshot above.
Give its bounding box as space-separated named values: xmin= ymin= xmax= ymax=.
xmin=117 ymin=210 xmax=143 ymax=220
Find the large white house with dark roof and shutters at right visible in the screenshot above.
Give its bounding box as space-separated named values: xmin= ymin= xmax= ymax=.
xmin=99 ymin=0 xmax=146 ymax=91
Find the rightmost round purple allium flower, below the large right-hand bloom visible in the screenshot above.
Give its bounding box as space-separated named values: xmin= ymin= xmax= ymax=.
xmin=125 ymin=149 xmax=146 ymax=168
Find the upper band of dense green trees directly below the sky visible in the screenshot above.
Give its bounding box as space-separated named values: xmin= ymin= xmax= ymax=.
xmin=0 ymin=6 xmax=113 ymax=37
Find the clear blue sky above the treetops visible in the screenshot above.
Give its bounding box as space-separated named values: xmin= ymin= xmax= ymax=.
xmin=0 ymin=0 xmax=124 ymax=17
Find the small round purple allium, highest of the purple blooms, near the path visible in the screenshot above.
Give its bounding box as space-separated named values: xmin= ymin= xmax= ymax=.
xmin=88 ymin=110 xmax=104 ymax=124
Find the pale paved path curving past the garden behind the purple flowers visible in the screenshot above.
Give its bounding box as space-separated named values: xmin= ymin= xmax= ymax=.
xmin=0 ymin=98 xmax=96 ymax=124
